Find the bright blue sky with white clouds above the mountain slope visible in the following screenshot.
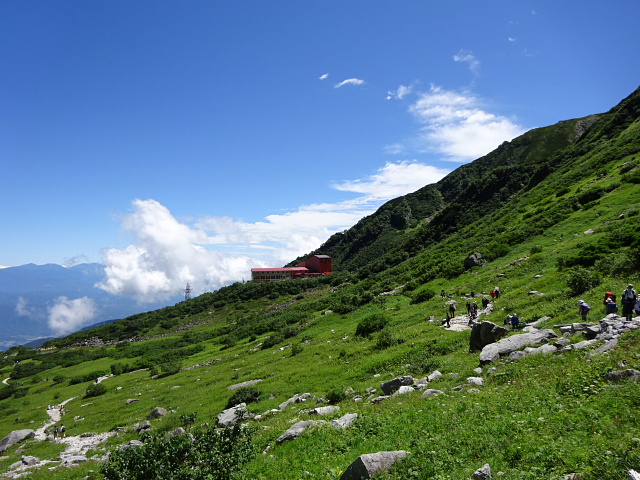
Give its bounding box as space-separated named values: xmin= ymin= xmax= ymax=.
xmin=0 ymin=0 xmax=640 ymax=301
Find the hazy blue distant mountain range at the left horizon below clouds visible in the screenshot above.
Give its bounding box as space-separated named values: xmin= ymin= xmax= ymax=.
xmin=0 ymin=263 xmax=174 ymax=350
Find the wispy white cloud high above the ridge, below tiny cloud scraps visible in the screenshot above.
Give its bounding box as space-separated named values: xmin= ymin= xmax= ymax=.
xmin=409 ymin=86 xmax=524 ymax=162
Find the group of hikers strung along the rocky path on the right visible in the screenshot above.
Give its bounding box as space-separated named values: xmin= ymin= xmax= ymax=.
xmin=440 ymin=284 xmax=640 ymax=330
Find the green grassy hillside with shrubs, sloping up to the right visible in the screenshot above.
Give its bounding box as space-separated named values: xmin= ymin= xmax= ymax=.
xmin=0 ymin=86 xmax=640 ymax=479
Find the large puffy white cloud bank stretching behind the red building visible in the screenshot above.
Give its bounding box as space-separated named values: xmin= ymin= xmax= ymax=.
xmin=97 ymin=161 xmax=448 ymax=302
